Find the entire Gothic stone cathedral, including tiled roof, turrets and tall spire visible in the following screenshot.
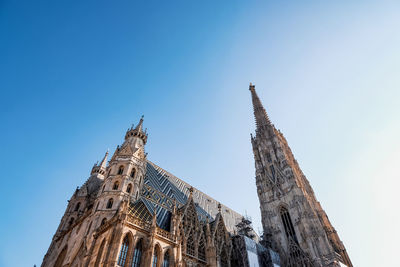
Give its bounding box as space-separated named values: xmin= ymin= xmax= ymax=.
xmin=42 ymin=84 xmax=352 ymax=267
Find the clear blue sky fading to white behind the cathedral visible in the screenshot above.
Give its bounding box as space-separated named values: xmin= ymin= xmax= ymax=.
xmin=0 ymin=0 xmax=400 ymax=267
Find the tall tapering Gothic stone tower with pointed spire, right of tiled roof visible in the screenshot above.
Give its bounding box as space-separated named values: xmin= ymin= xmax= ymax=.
xmin=250 ymin=84 xmax=352 ymax=266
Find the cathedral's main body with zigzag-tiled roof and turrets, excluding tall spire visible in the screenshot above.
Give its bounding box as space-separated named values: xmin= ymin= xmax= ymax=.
xmin=42 ymin=118 xmax=256 ymax=267
